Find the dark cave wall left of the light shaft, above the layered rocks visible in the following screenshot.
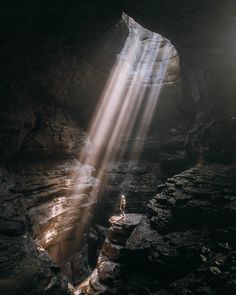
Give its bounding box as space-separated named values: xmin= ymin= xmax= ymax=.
xmin=0 ymin=1 xmax=127 ymax=158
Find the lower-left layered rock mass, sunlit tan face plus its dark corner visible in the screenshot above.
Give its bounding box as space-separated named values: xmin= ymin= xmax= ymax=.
xmin=0 ymin=160 xmax=98 ymax=294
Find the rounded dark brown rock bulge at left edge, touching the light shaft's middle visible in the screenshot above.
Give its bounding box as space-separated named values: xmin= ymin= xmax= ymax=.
xmin=0 ymin=107 xmax=91 ymax=161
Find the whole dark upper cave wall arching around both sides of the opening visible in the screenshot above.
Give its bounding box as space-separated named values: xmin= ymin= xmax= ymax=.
xmin=0 ymin=0 xmax=236 ymax=163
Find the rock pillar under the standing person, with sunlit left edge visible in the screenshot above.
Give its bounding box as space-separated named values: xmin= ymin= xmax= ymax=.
xmin=74 ymin=214 xmax=142 ymax=295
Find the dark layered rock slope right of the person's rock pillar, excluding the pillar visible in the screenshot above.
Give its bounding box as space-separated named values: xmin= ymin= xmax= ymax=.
xmin=121 ymin=165 xmax=236 ymax=294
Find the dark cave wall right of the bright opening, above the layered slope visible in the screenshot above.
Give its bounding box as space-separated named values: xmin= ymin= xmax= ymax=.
xmin=125 ymin=0 xmax=236 ymax=162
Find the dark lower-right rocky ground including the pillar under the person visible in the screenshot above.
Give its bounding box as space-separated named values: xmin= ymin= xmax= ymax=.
xmin=77 ymin=164 xmax=236 ymax=295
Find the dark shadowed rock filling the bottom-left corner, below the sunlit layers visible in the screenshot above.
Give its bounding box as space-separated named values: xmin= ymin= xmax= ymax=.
xmin=0 ymin=163 xmax=67 ymax=295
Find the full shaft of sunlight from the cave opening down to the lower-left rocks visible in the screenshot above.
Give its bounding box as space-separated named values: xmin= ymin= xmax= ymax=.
xmin=44 ymin=15 xmax=177 ymax=282
